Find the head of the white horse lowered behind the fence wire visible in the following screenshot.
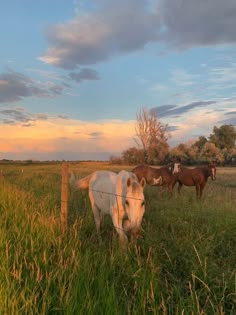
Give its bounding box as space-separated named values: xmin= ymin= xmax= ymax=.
xmin=124 ymin=178 xmax=146 ymax=236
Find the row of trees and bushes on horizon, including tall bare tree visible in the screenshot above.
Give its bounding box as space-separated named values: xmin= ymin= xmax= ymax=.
xmin=110 ymin=108 xmax=236 ymax=165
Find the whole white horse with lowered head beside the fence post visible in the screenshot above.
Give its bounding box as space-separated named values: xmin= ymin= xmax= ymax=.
xmin=70 ymin=171 xmax=145 ymax=242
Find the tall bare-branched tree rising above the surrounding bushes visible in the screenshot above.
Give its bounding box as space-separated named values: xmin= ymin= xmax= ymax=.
xmin=135 ymin=108 xmax=169 ymax=163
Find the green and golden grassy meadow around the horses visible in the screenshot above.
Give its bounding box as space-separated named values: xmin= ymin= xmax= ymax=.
xmin=0 ymin=162 xmax=236 ymax=315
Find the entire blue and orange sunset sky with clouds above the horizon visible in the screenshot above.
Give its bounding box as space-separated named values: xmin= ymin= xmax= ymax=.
xmin=0 ymin=0 xmax=236 ymax=160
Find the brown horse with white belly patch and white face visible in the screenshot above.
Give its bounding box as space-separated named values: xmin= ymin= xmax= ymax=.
xmin=132 ymin=162 xmax=180 ymax=193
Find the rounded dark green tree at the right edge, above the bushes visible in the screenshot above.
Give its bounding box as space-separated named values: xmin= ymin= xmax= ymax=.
xmin=209 ymin=125 xmax=236 ymax=150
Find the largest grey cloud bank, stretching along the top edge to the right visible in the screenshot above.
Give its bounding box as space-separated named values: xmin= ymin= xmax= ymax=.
xmin=39 ymin=0 xmax=236 ymax=69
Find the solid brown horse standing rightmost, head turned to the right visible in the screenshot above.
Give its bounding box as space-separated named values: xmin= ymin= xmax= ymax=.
xmin=172 ymin=164 xmax=216 ymax=198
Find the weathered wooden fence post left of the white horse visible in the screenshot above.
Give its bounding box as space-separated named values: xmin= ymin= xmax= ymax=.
xmin=61 ymin=161 xmax=69 ymax=233
